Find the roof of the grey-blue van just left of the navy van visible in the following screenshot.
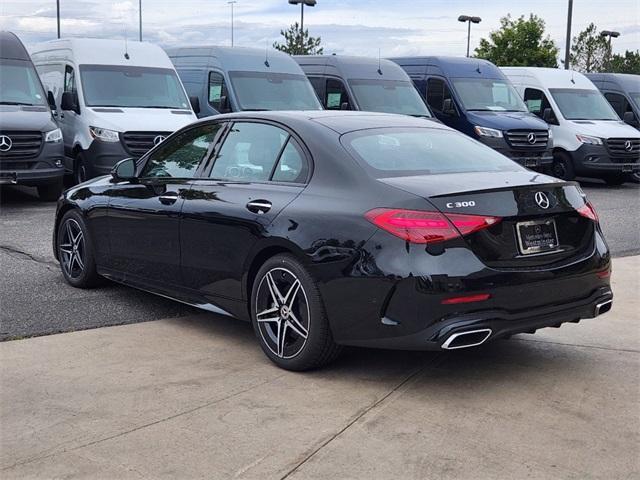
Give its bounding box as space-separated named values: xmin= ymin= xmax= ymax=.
xmin=293 ymin=55 xmax=411 ymax=82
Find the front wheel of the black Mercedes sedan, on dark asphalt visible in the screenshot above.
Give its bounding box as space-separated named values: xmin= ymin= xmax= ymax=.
xmin=56 ymin=210 xmax=100 ymax=288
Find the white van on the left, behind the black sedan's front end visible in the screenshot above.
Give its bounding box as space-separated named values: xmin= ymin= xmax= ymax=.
xmin=31 ymin=38 xmax=196 ymax=182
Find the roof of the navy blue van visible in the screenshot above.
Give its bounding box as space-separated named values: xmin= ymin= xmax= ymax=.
xmin=391 ymin=56 xmax=505 ymax=80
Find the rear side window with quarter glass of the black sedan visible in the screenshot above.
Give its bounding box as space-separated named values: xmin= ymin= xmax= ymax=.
xmin=210 ymin=122 xmax=308 ymax=182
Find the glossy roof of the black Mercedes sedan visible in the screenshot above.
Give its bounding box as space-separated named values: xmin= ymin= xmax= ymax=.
xmin=195 ymin=110 xmax=451 ymax=134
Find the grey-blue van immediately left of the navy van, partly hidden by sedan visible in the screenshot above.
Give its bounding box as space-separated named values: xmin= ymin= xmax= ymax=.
xmin=293 ymin=55 xmax=433 ymax=118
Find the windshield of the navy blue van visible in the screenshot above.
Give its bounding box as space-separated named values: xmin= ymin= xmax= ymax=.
xmin=452 ymin=78 xmax=527 ymax=112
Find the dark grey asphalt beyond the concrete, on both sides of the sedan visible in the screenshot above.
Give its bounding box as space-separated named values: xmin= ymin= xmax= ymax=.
xmin=0 ymin=177 xmax=640 ymax=340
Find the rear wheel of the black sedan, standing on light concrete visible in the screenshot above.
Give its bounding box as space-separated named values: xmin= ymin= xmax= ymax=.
xmin=250 ymin=254 xmax=342 ymax=371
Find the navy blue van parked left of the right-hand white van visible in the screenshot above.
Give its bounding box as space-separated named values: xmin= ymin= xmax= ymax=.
xmin=391 ymin=57 xmax=553 ymax=169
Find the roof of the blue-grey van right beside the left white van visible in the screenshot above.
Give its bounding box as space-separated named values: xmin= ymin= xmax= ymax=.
xmin=166 ymin=45 xmax=303 ymax=75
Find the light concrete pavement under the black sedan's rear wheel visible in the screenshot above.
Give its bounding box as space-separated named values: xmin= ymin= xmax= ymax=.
xmin=0 ymin=256 xmax=640 ymax=479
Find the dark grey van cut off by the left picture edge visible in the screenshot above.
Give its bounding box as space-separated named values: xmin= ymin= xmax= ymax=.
xmin=0 ymin=32 xmax=64 ymax=200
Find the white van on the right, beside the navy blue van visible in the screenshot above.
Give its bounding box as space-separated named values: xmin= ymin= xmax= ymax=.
xmin=502 ymin=67 xmax=640 ymax=185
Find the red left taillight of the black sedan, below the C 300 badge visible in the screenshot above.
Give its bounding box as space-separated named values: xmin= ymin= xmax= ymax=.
xmin=365 ymin=208 xmax=501 ymax=243
